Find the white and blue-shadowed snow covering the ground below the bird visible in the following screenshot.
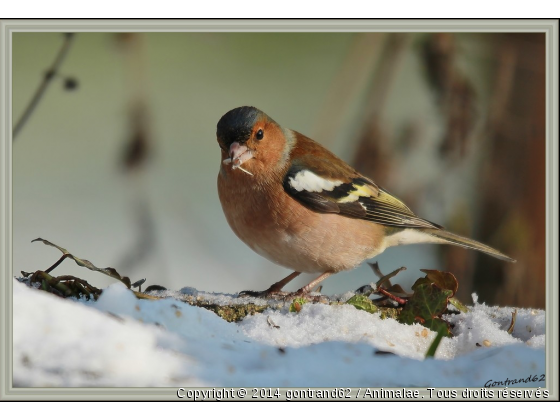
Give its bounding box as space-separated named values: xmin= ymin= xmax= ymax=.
xmin=13 ymin=280 xmax=545 ymax=388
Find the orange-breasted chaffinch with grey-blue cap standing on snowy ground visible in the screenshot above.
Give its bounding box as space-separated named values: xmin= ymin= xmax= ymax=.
xmin=216 ymin=106 xmax=515 ymax=296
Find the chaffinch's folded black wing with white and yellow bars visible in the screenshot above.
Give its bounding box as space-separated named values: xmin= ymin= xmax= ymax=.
xmin=283 ymin=156 xmax=441 ymax=229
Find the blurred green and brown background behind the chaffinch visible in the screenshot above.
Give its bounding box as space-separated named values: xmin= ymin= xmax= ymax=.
xmin=12 ymin=32 xmax=545 ymax=307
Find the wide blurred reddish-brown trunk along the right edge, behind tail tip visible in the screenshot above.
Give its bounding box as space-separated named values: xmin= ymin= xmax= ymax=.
xmin=474 ymin=33 xmax=547 ymax=307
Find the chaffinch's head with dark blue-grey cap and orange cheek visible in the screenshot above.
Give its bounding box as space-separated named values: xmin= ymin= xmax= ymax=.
xmin=216 ymin=106 xmax=286 ymax=175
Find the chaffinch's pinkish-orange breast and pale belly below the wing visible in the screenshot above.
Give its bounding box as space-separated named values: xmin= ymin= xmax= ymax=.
xmin=218 ymin=168 xmax=385 ymax=273
